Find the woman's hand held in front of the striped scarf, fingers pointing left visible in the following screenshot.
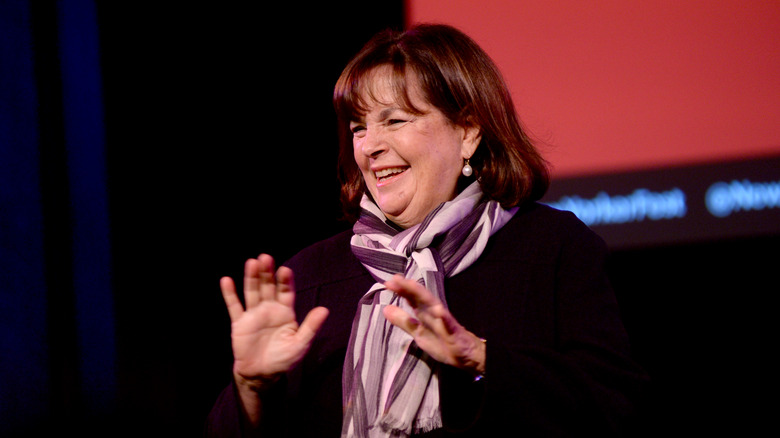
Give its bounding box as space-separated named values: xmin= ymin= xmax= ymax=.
xmin=384 ymin=275 xmax=485 ymax=376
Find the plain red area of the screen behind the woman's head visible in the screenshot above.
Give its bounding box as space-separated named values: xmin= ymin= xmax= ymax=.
xmin=406 ymin=0 xmax=780 ymax=177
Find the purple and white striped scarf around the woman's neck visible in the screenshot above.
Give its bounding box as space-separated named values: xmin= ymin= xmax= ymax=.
xmin=341 ymin=182 xmax=517 ymax=438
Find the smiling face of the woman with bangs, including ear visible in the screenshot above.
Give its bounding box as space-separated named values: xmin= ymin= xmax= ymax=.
xmin=350 ymin=67 xmax=479 ymax=228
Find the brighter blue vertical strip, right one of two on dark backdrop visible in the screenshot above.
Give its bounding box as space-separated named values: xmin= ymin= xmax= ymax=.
xmin=58 ymin=0 xmax=116 ymax=413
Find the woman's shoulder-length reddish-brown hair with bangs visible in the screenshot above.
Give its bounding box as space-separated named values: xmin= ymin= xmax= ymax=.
xmin=333 ymin=24 xmax=549 ymax=219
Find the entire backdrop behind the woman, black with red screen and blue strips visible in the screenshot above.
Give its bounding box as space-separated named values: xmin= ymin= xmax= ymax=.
xmin=0 ymin=0 xmax=780 ymax=436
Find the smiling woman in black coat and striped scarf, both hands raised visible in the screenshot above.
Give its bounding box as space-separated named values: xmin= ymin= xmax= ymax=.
xmin=208 ymin=25 xmax=645 ymax=437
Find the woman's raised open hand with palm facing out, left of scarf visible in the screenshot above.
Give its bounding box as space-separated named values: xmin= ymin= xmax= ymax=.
xmin=220 ymin=254 xmax=328 ymax=394
